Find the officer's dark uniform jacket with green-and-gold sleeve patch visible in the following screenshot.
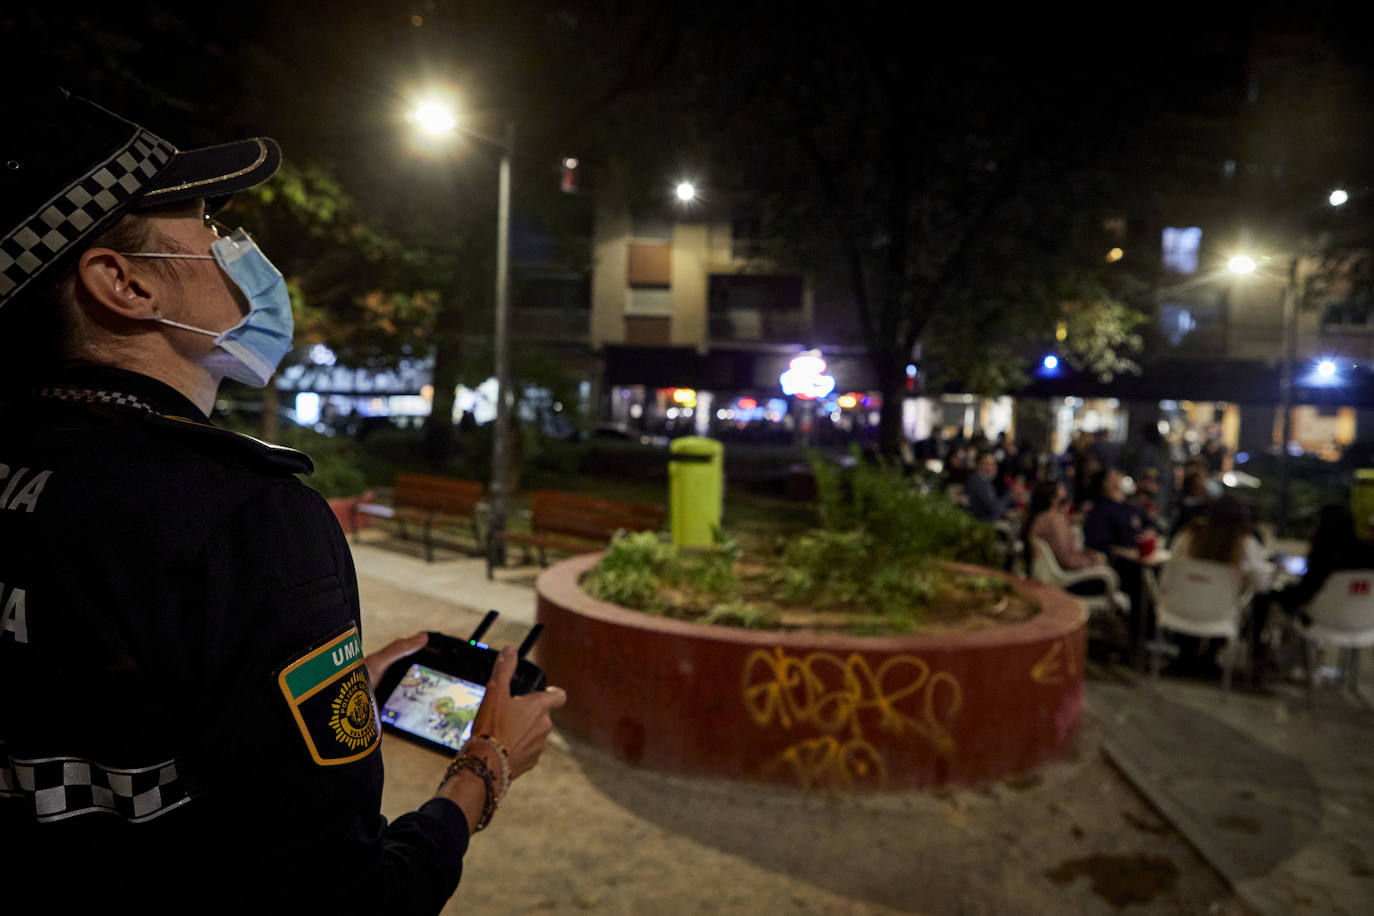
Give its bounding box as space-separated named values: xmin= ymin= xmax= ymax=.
xmin=0 ymin=367 xmax=469 ymax=916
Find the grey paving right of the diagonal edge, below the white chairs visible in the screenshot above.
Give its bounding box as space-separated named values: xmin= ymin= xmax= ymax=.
xmin=1087 ymin=666 xmax=1374 ymax=915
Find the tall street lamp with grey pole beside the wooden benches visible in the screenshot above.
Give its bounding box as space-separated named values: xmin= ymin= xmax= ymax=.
xmin=411 ymin=102 xmax=515 ymax=564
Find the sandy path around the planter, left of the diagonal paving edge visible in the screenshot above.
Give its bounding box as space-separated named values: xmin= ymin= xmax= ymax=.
xmin=354 ymin=542 xmax=1248 ymax=913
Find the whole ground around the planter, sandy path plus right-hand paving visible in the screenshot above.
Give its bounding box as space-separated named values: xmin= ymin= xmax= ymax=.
xmin=343 ymin=536 xmax=1374 ymax=913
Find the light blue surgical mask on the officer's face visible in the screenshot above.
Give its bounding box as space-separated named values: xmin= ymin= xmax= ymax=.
xmin=126 ymin=228 xmax=295 ymax=389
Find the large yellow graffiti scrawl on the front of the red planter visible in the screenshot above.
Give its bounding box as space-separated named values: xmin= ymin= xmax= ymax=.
xmin=741 ymin=648 xmax=963 ymax=788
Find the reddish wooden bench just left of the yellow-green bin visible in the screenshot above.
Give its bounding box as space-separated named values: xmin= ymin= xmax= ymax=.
xmin=486 ymin=490 xmax=668 ymax=578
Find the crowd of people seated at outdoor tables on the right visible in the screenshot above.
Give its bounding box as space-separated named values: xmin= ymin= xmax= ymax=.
xmin=941 ymin=423 xmax=1374 ymax=674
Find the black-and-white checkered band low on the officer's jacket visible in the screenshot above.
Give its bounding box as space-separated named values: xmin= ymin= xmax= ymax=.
xmin=0 ymin=746 xmax=198 ymax=824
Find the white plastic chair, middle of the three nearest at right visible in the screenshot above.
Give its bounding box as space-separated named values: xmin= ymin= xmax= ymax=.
xmin=1145 ymin=556 xmax=1253 ymax=691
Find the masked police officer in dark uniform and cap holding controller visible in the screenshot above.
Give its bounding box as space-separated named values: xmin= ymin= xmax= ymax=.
xmin=0 ymin=91 xmax=563 ymax=913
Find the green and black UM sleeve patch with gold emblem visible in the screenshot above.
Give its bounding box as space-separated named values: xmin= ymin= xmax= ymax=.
xmin=276 ymin=626 xmax=382 ymax=766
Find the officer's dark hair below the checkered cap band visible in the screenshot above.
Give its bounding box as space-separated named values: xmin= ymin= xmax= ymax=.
xmin=0 ymin=213 xmax=177 ymax=393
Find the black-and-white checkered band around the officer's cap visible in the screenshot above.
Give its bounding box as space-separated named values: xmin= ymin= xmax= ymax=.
xmin=0 ymin=128 xmax=177 ymax=308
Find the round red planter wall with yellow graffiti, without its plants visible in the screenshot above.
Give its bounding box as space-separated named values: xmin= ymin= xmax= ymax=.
xmin=536 ymin=553 xmax=1088 ymax=792
